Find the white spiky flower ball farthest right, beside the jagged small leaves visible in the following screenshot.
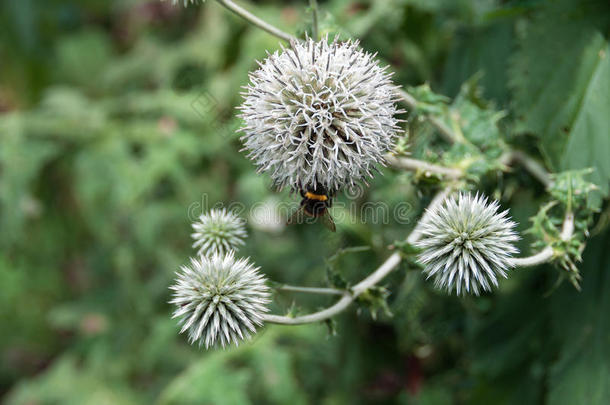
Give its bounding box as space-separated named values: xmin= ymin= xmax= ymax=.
xmin=416 ymin=193 xmax=519 ymax=295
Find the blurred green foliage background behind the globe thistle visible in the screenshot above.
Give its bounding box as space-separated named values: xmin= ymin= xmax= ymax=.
xmin=0 ymin=0 xmax=610 ymax=405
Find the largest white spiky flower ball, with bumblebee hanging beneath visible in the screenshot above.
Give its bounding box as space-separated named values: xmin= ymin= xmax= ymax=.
xmin=240 ymin=38 xmax=402 ymax=193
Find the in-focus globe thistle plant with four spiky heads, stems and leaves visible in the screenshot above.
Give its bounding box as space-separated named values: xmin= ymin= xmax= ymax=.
xmin=165 ymin=0 xmax=592 ymax=347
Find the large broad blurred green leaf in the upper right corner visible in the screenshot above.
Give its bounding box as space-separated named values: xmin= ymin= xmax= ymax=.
xmin=510 ymin=1 xmax=610 ymax=195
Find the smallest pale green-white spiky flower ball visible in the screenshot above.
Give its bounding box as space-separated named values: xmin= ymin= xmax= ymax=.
xmin=191 ymin=208 xmax=248 ymax=256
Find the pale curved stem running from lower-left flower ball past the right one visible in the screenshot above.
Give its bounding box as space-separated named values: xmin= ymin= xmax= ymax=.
xmin=264 ymin=187 xmax=452 ymax=325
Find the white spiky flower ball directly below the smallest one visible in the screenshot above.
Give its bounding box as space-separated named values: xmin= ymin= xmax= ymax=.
xmin=170 ymin=252 xmax=270 ymax=349
